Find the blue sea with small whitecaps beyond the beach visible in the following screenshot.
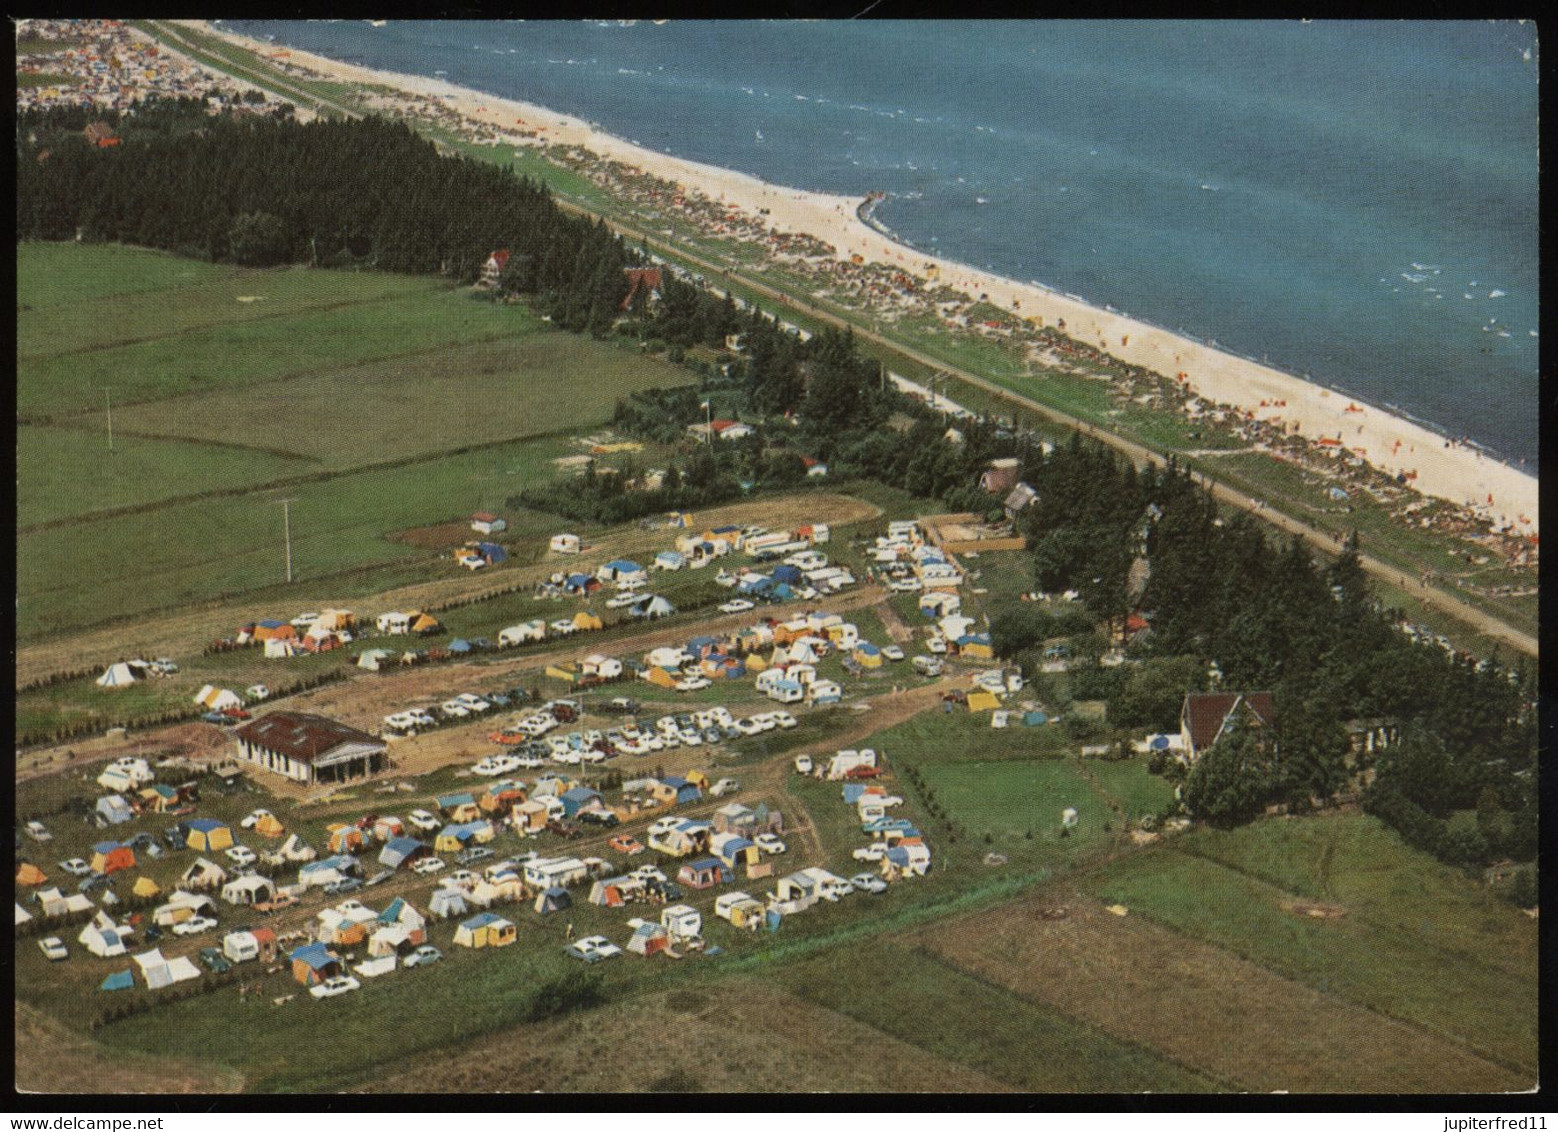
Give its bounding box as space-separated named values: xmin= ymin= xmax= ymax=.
xmin=224 ymin=20 xmax=1539 ymax=467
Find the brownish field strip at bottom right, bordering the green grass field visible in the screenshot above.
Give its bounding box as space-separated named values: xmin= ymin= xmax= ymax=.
xmin=916 ymin=894 xmax=1533 ymax=1093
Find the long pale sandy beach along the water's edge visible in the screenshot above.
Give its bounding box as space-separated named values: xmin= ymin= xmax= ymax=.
xmin=189 ymin=22 xmax=1538 ymax=534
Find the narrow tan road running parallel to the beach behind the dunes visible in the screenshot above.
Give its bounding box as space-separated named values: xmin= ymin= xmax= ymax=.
xmin=553 ymin=210 xmax=1536 ymax=657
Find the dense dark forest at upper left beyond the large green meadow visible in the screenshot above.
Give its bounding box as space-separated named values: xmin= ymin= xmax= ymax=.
xmin=16 ymin=98 xmax=633 ymax=332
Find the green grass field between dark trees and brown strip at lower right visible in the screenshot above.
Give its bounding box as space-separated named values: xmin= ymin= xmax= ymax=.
xmin=1089 ymin=816 xmax=1538 ymax=1070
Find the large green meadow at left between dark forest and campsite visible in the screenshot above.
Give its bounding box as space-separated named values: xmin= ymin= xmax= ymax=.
xmin=17 ymin=244 xmax=692 ymax=640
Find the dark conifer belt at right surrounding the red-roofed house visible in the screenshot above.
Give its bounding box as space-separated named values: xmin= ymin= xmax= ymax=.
xmin=991 ymin=439 xmax=1536 ymax=864
